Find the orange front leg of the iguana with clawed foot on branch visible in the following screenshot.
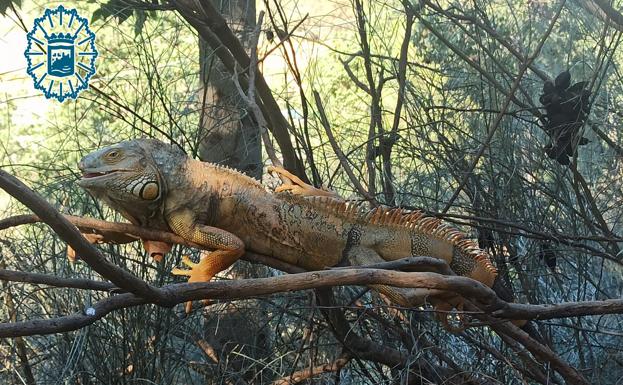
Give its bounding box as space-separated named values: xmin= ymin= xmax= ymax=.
xmin=167 ymin=210 xmax=244 ymax=312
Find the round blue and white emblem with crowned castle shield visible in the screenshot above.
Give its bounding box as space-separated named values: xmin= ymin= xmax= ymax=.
xmin=24 ymin=5 xmax=97 ymax=102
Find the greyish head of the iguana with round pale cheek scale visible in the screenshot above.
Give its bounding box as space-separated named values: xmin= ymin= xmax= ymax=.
xmin=78 ymin=139 xmax=180 ymax=225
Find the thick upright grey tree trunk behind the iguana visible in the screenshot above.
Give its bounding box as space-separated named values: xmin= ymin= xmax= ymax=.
xmin=198 ymin=0 xmax=271 ymax=384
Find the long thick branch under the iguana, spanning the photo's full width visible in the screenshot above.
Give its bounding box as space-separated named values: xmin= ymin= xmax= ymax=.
xmin=0 ymin=269 xmax=623 ymax=338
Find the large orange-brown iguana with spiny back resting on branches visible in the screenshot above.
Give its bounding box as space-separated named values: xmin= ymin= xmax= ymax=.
xmin=79 ymin=139 xmax=496 ymax=326
